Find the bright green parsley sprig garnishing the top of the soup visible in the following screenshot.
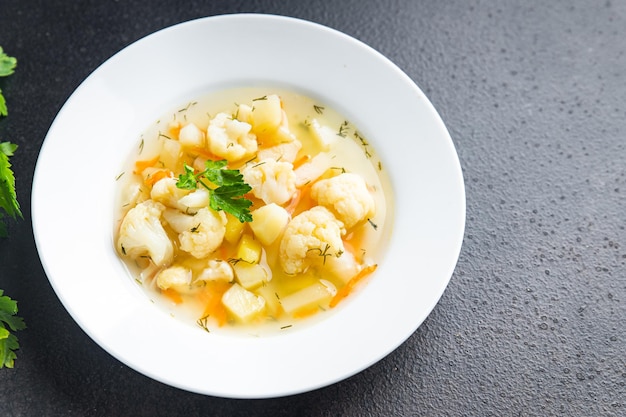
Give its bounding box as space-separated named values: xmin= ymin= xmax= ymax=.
xmin=176 ymin=160 xmax=252 ymax=223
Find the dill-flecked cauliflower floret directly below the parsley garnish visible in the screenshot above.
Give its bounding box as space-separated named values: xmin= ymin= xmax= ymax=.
xmin=163 ymin=207 xmax=226 ymax=258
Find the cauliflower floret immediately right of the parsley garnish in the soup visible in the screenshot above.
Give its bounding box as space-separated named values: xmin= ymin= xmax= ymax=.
xmin=241 ymin=159 xmax=296 ymax=205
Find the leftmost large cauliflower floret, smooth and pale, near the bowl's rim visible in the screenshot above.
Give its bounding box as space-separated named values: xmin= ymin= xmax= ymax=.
xmin=117 ymin=200 xmax=174 ymax=266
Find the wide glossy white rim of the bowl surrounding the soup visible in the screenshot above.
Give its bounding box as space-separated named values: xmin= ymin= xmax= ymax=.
xmin=32 ymin=14 xmax=465 ymax=398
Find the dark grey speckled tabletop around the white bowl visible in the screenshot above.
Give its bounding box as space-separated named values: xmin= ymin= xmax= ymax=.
xmin=0 ymin=0 xmax=626 ymax=416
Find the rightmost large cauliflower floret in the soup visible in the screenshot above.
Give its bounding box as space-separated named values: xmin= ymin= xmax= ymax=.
xmin=311 ymin=173 xmax=375 ymax=229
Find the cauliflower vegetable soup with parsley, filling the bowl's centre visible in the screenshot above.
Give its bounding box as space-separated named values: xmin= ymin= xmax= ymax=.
xmin=114 ymin=88 xmax=388 ymax=333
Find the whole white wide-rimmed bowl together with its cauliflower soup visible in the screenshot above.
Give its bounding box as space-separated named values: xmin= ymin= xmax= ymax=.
xmin=32 ymin=14 xmax=465 ymax=398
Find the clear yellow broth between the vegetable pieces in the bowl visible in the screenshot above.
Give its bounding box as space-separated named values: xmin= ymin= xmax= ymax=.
xmin=114 ymin=88 xmax=390 ymax=335
